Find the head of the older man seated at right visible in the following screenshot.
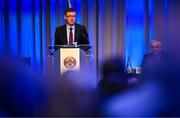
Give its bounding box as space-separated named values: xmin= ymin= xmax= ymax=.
xmin=151 ymin=40 xmax=161 ymax=55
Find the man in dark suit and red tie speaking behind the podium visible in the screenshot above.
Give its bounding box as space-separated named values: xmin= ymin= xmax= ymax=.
xmin=55 ymin=8 xmax=89 ymax=50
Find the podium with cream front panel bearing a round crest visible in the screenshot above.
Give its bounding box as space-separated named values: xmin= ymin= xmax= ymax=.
xmin=54 ymin=45 xmax=90 ymax=75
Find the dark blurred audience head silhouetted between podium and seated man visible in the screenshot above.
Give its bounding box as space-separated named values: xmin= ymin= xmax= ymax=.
xmin=99 ymin=57 xmax=127 ymax=95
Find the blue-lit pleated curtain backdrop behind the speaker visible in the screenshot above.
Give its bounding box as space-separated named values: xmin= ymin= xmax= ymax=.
xmin=0 ymin=0 xmax=179 ymax=78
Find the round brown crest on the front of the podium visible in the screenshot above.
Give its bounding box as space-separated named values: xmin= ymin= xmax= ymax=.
xmin=64 ymin=57 xmax=76 ymax=68
